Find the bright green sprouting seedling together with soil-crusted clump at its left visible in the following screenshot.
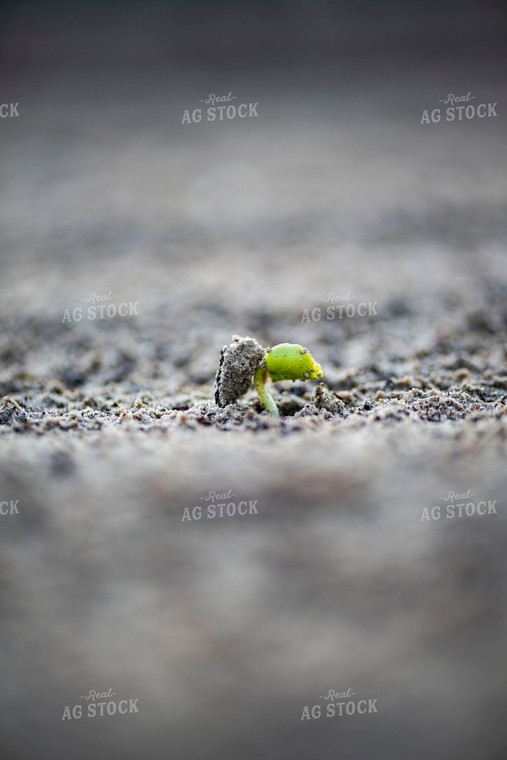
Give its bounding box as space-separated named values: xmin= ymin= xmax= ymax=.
xmin=215 ymin=335 xmax=322 ymax=417
